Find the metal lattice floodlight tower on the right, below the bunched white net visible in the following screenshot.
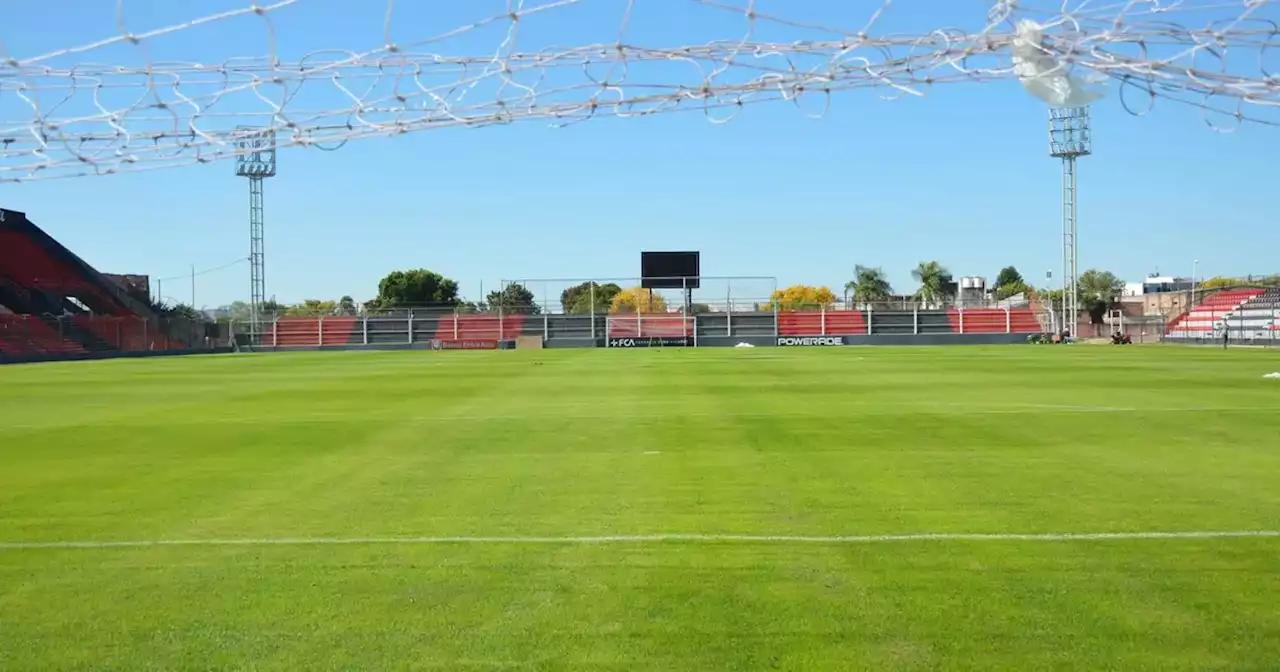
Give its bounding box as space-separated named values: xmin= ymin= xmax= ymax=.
xmin=1048 ymin=108 xmax=1093 ymax=338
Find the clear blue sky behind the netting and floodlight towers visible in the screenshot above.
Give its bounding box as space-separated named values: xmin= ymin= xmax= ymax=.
xmin=0 ymin=0 xmax=1280 ymax=307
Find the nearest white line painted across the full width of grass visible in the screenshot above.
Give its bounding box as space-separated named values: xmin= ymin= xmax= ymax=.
xmin=0 ymin=530 xmax=1280 ymax=550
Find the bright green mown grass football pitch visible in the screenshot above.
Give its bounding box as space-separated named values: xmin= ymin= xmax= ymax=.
xmin=0 ymin=346 xmax=1280 ymax=671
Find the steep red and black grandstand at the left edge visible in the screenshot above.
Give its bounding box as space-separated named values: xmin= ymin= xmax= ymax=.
xmin=0 ymin=209 xmax=198 ymax=358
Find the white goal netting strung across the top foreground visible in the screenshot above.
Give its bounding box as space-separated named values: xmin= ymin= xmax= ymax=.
xmin=0 ymin=0 xmax=1280 ymax=182
